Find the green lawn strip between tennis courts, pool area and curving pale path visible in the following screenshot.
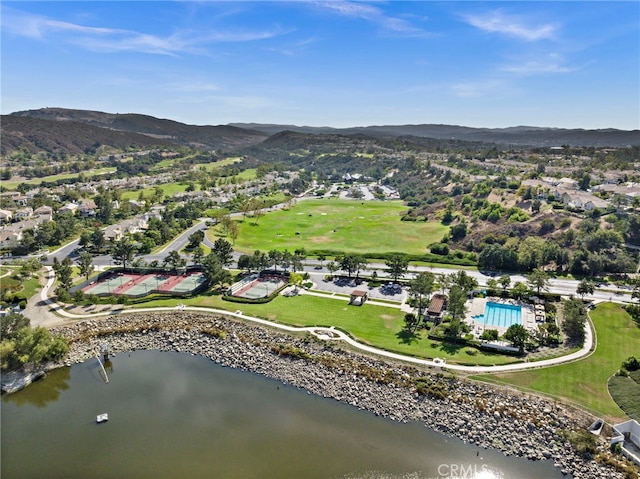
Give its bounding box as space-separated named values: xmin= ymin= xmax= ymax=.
xmin=129 ymin=295 xmax=517 ymax=365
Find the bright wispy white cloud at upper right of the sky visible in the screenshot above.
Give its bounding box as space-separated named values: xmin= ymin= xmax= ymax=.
xmin=463 ymin=10 xmax=558 ymax=41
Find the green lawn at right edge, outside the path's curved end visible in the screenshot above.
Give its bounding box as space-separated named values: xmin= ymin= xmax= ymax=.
xmin=475 ymin=303 xmax=640 ymax=422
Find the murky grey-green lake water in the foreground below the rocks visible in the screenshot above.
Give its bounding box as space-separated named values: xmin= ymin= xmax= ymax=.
xmin=0 ymin=351 xmax=562 ymax=479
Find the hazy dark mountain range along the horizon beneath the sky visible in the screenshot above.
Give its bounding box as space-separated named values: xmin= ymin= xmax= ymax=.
xmin=0 ymin=108 xmax=640 ymax=154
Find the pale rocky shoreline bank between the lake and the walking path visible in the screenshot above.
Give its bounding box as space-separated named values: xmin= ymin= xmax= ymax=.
xmin=2 ymin=311 xmax=624 ymax=479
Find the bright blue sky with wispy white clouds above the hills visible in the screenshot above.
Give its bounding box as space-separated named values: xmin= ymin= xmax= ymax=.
xmin=0 ymin=0 xmax=640 ymax=129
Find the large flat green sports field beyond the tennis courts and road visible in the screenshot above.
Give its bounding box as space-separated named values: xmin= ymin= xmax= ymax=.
xmin=229 ymin=199 xmax=449 ymax=255
